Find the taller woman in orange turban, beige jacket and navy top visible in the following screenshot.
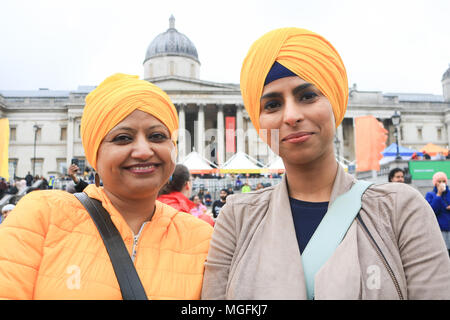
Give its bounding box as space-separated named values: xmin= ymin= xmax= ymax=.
xmin=202 ymin=28 xmax=450 ymax=299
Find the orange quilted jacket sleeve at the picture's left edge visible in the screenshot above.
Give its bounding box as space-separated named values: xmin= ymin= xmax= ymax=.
xmin=0 ymin=191 xmax=50 ymax=299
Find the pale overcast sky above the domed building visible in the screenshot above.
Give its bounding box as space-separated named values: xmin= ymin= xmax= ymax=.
xmin=0 ymin=0 xmax=450 ymax=95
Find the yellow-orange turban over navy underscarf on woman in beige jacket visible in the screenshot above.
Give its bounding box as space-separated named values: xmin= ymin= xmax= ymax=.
xmin=240 ymin=28 xmax=348 ymax=131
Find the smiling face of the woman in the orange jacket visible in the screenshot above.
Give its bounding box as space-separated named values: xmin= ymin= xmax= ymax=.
xmin=97 ymin=110 xmax=176 ymax=199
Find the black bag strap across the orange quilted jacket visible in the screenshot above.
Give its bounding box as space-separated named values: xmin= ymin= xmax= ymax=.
xmin=74 ymin=192 xmax=148 ymax=300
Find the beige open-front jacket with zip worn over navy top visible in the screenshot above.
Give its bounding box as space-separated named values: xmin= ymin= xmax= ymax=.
xmin=202 ymin=167 xmax=450 ymax=300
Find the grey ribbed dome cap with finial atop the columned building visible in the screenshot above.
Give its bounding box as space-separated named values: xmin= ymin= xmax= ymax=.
xmin=144 ymin=15 xmax=199 ymax=63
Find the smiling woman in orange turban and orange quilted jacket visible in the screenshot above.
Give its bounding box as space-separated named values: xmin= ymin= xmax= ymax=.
xmin=0 ymin=74 xmax=212 ymax=299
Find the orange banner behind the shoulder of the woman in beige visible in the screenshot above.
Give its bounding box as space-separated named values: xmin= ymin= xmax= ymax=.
xmin=355 ymin=116 xmax=388 ymax=171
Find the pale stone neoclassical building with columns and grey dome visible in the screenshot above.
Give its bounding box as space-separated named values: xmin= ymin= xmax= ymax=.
xmin=0 ymin=16 xmax=450 ymax=177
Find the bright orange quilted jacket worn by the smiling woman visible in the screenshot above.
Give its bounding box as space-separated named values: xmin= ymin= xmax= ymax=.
xmin=0 ymin=185 xmax=213 ymax=299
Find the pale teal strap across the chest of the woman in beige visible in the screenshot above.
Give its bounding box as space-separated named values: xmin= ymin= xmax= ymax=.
xmin=302 ymin=181 xmax=373 ymax=300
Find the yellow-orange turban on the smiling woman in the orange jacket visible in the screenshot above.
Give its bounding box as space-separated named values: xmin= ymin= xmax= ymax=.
xmin=81 ymin=73 xmax=178 ymax=170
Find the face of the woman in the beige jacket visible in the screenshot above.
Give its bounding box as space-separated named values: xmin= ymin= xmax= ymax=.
xmin=259 ymin=76 xmax=335 ymax=164
